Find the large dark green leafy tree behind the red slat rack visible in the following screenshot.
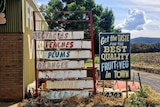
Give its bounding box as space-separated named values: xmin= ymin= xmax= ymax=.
xmin=40 ymin=0 xmax=121 ymax=54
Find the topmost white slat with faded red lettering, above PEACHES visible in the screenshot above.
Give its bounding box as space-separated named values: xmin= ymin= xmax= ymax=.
xmin=32 ymin=31 xmax=84 ymax=40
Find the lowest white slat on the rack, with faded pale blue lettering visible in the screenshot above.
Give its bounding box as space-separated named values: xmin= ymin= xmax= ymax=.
xmin=40 ymin=90 xmax=92 ymax=99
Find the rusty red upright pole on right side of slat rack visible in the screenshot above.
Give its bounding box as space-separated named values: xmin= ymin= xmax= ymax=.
xmin=89 ymin=11 xmax=96 ymax=94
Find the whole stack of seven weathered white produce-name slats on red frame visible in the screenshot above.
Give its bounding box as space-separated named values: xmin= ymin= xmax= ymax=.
xmin=33 ymin=31 xmax=94 ymax=99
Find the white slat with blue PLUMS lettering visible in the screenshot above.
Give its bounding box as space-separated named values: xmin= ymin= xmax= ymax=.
xmin=37 ymin=50 xmax=92 ymax=60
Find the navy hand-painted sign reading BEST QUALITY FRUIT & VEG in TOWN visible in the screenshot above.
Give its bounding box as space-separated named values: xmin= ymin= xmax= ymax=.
xmin=99 ymin=33 xmax=130 ymax=80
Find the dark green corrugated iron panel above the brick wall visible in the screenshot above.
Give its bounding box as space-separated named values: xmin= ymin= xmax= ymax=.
xmin=0 ymin=0 xmax=22 ymax=32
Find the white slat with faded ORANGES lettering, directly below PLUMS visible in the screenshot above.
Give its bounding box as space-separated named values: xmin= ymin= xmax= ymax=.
xmin=37 ymin=60 xmax=84 ymax=69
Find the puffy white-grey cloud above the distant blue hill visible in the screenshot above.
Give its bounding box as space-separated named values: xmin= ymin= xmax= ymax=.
xmin=117 ymin=9 xmax=151 ymax=30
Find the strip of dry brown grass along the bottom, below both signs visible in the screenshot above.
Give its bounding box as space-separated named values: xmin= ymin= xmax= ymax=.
xmin=19 ymin=86 xmax=160 ymax=107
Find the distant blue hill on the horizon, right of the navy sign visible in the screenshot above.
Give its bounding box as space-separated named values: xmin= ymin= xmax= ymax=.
xmin=131 ymin=37 xmax=160 ymax=44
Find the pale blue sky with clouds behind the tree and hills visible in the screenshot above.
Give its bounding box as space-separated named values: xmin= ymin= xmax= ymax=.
xmin=35 ymin=0 xmax=160 ymax=38
